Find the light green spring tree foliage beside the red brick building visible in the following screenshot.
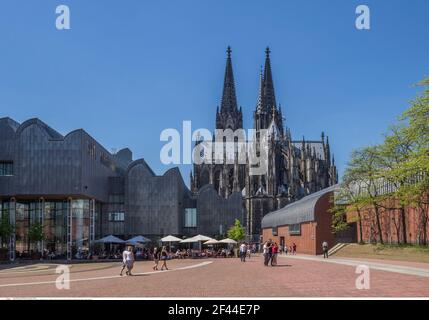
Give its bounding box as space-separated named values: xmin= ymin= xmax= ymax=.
xmin=338 ymin=78 xmax=429 ymax=242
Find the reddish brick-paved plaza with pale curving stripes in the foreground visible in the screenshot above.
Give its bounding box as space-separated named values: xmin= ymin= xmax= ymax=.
xmin=0 ymin=255 xmax=429 ymax=298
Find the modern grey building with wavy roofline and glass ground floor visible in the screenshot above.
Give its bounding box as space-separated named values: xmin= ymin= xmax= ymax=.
xmin=0 ymin=118 xmax=244 ymax=260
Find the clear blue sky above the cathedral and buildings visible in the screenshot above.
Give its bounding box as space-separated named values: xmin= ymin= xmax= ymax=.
xmin=0 ymin=0 xmax=429 ymax=183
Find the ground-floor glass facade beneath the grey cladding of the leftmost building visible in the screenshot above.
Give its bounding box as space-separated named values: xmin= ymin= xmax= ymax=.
xmin=0 ymin=199 xmax=101 ymax=259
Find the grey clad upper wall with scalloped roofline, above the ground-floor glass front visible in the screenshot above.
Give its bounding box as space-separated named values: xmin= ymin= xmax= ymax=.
xmin=0 ymin=119 xmax=123 ymax=202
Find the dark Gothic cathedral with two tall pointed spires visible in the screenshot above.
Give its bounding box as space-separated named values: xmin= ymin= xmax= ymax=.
xmin=190 ymin=47 xmax=338 ymax=241
